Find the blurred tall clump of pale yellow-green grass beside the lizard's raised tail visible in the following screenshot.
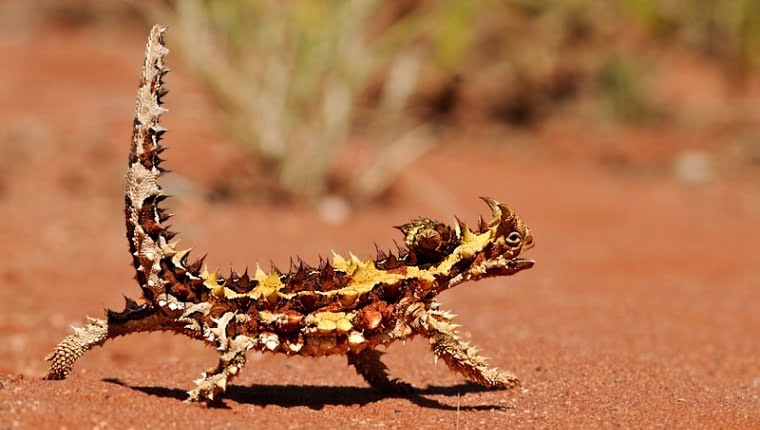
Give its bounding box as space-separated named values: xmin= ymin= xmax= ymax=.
xmin=142 ymin=0 xmax=442 ymax=202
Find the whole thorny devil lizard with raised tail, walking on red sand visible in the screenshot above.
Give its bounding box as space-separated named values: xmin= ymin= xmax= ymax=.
xmin=47 ymin=26 xmax=533 ymax=403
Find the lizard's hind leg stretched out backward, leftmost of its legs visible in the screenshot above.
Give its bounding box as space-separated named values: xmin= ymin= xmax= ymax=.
xmin=45 ymin=298 xmax=171 ymax=379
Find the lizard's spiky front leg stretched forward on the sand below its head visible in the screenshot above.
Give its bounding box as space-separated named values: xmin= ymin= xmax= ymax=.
xmin=412 ymin=306 xmax=521 ymax=389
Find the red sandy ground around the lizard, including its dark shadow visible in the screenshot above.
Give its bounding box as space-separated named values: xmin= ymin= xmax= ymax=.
xmin=0 ymin=18 xmax=760 ymax=429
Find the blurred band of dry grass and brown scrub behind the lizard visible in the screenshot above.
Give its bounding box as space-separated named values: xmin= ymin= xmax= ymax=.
xmin=29 ymin=0 xmax=760 ymax=199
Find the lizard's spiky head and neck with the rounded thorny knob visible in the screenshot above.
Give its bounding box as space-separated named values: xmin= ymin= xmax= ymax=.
xmin=399 ymin=197 xmax=534 ymax=289
